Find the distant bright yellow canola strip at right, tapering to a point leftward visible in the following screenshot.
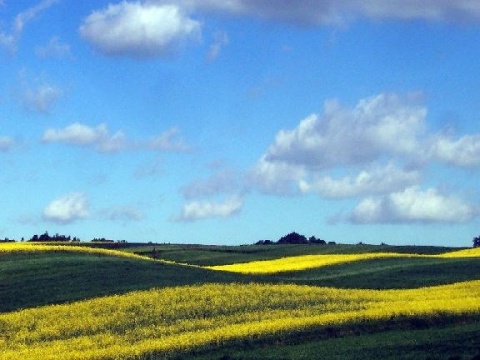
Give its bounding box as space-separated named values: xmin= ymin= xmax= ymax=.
xmin=208 ymin=248 xmax=480 ymax=274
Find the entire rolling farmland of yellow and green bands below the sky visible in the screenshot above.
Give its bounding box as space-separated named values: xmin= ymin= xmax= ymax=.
xmin=0 ymin=244 xmax=480 ymax=359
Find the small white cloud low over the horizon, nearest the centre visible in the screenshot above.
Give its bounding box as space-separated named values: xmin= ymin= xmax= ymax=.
xmin=174 ymin=197 xmax=243 ymax=222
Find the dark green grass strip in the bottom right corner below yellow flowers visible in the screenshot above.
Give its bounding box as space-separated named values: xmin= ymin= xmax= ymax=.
xmin=187 ymin=321 xmax=480 ymax=360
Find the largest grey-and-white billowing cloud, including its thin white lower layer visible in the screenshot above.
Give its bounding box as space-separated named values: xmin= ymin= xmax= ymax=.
xmin=250 ymin=94 xmax=427 ymax=197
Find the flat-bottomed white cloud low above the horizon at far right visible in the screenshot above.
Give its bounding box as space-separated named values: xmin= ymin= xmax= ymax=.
xmin=349 ymin=186 xmax=478 ymax=224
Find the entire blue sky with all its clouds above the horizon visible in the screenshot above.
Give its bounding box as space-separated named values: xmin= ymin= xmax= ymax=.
xmin=0 ymin=0 xmax=480 ymax=246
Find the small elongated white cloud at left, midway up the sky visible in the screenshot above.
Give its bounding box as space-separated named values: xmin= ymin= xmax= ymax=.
xmin=42 ymin=123 xmax=126 ymax=152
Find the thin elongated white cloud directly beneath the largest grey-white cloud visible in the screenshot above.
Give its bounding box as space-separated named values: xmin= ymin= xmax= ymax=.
xmin=299 ymin=164 xmax=420 ymax=198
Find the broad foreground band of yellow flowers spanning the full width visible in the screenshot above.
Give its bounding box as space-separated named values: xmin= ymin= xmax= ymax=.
xmin=0 ymin=281 xmax=480 ymax=360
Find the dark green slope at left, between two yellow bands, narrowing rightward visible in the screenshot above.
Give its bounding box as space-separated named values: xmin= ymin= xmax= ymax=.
xmin=0 ymin=251 xmax=244 ymax=312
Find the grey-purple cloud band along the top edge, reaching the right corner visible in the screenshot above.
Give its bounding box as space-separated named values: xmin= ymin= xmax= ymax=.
xmin=150 ymin=0 xmax=480 ymax=25
